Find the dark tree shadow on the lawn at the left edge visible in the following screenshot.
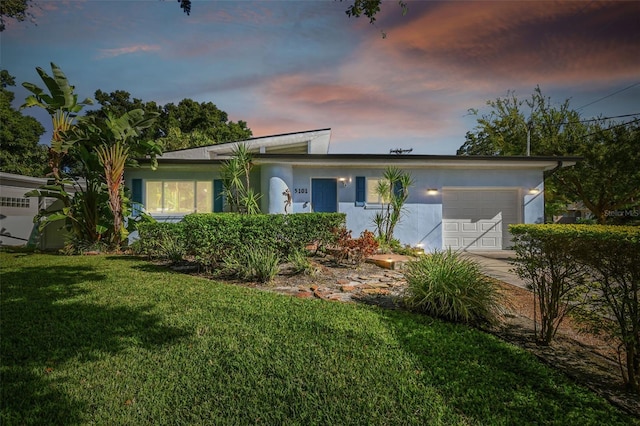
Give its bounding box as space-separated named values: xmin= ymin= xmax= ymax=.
xmin=0 ymin=265 xmax=187 ymax=424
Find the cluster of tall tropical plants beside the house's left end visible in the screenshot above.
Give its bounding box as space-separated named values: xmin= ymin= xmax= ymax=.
xmin=23 ymin=63 xmax=161 ymax=250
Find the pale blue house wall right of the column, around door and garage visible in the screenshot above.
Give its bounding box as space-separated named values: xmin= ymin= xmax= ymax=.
xmin=291 ymin=167 xmax=544 ymax=251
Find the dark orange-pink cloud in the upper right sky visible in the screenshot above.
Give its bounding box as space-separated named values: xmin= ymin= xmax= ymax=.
xmin=371 ymin=2 xmax=640 ymax=85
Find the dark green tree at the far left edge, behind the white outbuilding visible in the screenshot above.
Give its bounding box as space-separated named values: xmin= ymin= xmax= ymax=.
xmin=0 ymin=70 xmax=47 ymax=177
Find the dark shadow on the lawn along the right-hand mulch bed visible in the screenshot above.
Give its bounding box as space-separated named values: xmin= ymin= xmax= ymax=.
xmin=380 ymin=310 xmax=624 ymax=424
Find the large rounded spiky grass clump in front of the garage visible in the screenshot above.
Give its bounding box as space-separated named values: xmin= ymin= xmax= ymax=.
xmin=403 ymin=250 xmax=502 ymax=324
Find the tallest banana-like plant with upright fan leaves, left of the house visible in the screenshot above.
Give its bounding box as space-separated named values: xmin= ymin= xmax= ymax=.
xmin=20 ymin=62 xmax=93 ymax=184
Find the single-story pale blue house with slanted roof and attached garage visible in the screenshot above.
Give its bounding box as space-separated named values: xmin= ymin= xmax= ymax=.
xmin=125 ymin=129 xmax=577 ymax=251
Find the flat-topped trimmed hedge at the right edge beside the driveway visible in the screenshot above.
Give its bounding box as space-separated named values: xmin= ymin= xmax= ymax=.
xmin=509 ymin=225 xmax=640 ymax=393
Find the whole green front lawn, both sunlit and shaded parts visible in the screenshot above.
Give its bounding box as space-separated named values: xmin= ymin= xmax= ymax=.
xmin=0 ymin=253 xmax=639 ymax=425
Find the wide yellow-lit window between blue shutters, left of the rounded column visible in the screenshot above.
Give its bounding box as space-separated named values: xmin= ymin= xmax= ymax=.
xmin=145 ymin=180 xmax=213 ymax=214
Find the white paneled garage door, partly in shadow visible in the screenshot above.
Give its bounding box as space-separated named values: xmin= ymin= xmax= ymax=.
xmin=442 ymin=189 xmax=521 ymax=250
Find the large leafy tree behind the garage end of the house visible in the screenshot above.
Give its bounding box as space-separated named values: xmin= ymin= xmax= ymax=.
xmin=457 ymin=87 xmax=640 ymax=223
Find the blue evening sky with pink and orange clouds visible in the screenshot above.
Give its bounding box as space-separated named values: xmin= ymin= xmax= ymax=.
xmin=0 ymin=0 xmax=640 ymax=154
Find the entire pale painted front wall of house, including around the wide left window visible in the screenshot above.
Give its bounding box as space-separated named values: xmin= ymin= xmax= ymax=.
xmin=126 ymin=164 xmax=544 ymax=251
